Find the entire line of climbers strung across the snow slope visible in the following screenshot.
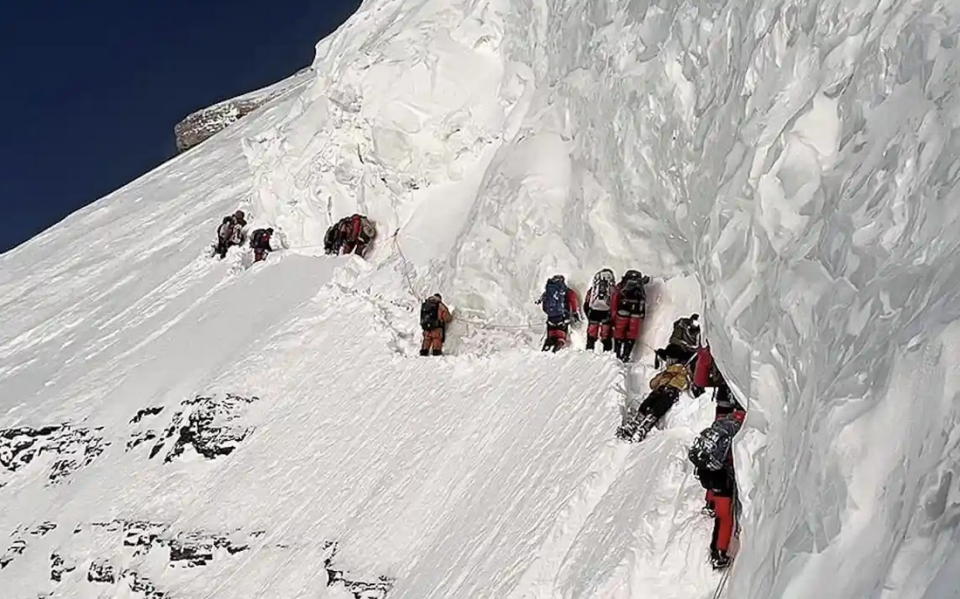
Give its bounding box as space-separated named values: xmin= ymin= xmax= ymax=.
xmin=215 ymin=218 xmax=746 ymax=569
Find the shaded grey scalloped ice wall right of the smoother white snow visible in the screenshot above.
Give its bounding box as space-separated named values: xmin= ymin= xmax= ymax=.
xmin=488 ymin=1 xmax=960 ymax=598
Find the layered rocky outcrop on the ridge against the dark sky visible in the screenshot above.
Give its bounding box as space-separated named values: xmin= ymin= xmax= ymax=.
xmin=173 ymin=68 xmax=312 ymax=152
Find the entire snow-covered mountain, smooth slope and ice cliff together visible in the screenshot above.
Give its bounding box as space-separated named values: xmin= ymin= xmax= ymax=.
xmin=0 ymin=0 xmax=960 ymax=599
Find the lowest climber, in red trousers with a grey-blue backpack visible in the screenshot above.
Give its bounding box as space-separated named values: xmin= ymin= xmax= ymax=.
xmin=687 ymin=410 xmax=746 ymax=570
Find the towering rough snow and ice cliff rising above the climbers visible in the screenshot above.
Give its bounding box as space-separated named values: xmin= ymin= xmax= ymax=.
xmin=242 ymin=0 xmax=960 ymax=597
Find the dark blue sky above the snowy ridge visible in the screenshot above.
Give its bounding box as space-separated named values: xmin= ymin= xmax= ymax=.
xmin=0 ymin=0 xmax=360 ymax=252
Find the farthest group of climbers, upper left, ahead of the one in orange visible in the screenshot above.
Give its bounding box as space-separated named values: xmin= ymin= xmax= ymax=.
xmin=214 ymin=210 xmax=377 ymax=262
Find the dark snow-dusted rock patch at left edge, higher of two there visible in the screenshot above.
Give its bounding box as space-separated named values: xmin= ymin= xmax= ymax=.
xmin=0 ymin=424 xmax=110 ymax=487
